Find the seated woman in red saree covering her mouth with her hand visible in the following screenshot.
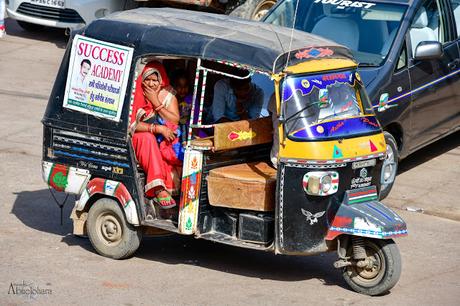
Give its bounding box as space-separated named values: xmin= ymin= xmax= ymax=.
xmin=130 ymin=61 xmax=181 ymax=208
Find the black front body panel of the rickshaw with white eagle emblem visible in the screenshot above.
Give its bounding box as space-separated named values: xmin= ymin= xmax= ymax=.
xmin=276 ymin=159 xmax=383 ymax=255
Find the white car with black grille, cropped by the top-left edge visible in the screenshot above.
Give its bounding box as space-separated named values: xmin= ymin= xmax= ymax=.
xmin=6 ymin=0 xmax=131 ymax=31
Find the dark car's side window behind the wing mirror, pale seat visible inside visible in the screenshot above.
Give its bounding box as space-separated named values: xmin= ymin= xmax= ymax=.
xmin=409 ymin=0 xmax=446 ymax=56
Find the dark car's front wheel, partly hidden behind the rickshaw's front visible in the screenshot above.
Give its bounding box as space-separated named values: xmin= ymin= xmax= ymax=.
xmin=379 ymin=132 xmax=399 ymax=200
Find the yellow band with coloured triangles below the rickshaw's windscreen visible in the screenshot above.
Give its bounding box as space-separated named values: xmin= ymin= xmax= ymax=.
xmin=279 ymin=133 xmax=386 ymax=160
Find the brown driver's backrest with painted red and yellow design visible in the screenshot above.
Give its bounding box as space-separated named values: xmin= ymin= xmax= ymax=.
xmin=191 ymin=117 xmax=273 ymax=151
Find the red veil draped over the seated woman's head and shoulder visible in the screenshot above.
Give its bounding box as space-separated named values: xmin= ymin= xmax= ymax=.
xmin=130 ymin=61 xmax=169 ymax=129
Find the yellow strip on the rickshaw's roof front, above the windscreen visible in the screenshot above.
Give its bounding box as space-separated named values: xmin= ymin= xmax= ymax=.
xmin=285 ymin=58 xmax=357 ymax=74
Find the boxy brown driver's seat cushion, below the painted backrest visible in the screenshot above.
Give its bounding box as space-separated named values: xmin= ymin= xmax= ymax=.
xmin=207 ymin=162 xmax=277 ymax=211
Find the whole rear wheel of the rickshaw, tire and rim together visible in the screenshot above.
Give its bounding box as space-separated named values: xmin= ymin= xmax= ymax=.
xmin=86 ymin=198 xmax=142 ymax=259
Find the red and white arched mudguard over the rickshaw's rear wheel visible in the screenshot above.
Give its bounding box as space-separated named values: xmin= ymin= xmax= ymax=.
xmin=75 ymin=178 xmax=139 ymax=225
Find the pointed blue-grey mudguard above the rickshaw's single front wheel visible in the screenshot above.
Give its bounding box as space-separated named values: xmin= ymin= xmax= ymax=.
xmin=325 ymin=191 xmax=407 ymax=240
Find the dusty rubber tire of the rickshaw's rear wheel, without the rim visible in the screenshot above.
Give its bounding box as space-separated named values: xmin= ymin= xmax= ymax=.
xmin=86 ymin=198 xmax=142 ymax=259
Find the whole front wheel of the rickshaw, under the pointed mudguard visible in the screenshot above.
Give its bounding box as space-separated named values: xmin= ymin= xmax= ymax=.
xmin=342 ymin=239 xmax=401 ymax=295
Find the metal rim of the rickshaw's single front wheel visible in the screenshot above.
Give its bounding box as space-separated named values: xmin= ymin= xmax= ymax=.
xmin=347 ymin=243 xmax=386 ymax=287
